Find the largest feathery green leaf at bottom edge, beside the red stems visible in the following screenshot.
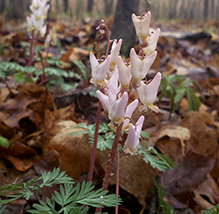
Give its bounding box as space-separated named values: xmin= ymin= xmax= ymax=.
xmin=29 ymin=181 xmax=121 ymax=214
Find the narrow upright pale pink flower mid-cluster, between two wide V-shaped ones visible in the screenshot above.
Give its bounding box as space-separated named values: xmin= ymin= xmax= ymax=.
xmin=117 ymin=56 xmax=132 ymax=88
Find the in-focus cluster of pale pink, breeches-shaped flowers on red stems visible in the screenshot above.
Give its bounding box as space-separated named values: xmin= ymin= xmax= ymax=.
xmin=90 ymin=11 xmax=161 ymax=154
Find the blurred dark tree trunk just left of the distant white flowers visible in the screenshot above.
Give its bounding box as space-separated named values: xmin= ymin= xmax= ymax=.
xmin=8 ymin=0 xmax=24 ymax=20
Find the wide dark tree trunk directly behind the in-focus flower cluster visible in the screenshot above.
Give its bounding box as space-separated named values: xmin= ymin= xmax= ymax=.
xmin=111 ymin=0 xmax=139 ymax=57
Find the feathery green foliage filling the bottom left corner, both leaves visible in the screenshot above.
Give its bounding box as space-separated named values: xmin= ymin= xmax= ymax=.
xmin=0 ymin=168 xmax=121 ymax=214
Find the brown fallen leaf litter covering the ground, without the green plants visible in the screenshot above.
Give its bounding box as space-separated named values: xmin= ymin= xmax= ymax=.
xmin=0 ymin=14 xmax=219 ymax=213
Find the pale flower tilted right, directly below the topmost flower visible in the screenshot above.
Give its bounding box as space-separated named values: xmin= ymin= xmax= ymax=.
xmin=143 ymin=28 xmax=160 ymax=56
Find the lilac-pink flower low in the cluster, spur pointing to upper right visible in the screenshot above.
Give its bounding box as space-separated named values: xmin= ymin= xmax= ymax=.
xmin=109 ymin=92 xmax=128 ymax=124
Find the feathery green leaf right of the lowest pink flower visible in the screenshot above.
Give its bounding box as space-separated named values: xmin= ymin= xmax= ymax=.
xmin=137 ymin=142 xmax=175 ymax=172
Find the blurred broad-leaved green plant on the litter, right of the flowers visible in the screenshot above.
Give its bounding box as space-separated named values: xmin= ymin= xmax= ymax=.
xmin=159 ymin=75 xmax=200 ymax=112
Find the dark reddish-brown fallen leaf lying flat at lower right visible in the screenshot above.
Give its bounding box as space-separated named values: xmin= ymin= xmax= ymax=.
xmin=162 ymin=151 xmax=215 ymax=197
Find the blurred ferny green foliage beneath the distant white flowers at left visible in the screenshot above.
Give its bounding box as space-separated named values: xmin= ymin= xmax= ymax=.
xmin=0 ymin=57 xmax=88 ymax=91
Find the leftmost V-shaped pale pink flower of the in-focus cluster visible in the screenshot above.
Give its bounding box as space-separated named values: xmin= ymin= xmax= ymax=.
xmin=90 ymin=52 xmax=110 ymax=87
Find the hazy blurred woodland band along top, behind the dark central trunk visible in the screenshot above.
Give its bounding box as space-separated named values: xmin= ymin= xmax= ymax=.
xmin=0 ymin=0 xmax=219 ymax=21
